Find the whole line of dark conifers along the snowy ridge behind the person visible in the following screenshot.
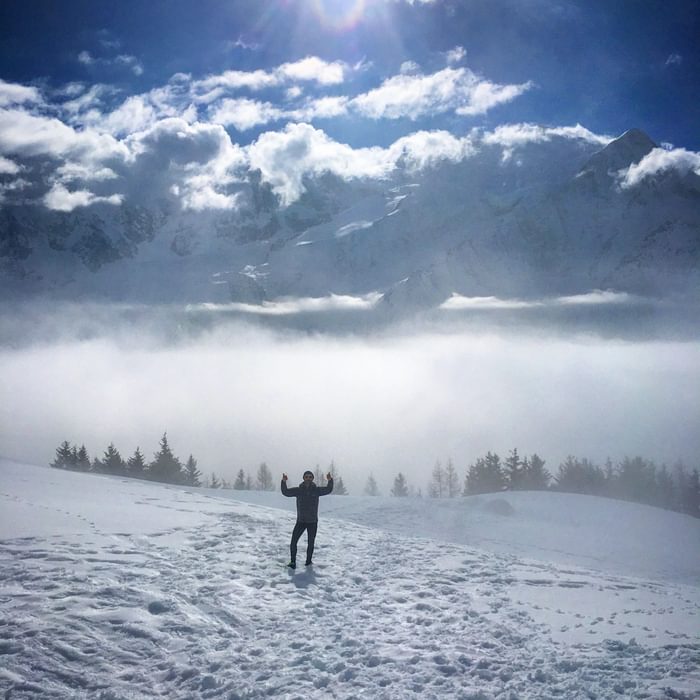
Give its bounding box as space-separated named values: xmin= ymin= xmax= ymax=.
xmin=50 ymin=434 xmax=700 ymax=518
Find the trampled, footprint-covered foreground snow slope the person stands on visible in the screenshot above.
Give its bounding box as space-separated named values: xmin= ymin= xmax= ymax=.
xmin=0 ymin=470 xmax=700 ymax=700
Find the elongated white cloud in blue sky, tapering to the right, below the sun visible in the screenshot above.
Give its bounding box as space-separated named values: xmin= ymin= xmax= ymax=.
xmin=352 ymin=68 xmax=531 ymax=120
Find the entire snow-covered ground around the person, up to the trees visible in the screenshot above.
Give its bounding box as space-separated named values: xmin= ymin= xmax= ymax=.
xmin=0 ymin=460 xmax=700 ymax=700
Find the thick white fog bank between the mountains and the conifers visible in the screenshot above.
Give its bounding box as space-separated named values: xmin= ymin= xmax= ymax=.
xmin=0 ymin=308 xmax=700 ymax=493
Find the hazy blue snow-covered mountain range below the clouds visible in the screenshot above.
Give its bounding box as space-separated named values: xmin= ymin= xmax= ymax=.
xmin=0 ymin=130 xmax=700 ymax=310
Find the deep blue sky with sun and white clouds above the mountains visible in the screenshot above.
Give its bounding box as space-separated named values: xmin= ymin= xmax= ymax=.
xmin=0 ymin=0 xmax=700 ymax=210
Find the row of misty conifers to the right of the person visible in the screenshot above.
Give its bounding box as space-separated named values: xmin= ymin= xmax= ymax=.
xmin=386 ymin=449 xmax=700 ymax=518
